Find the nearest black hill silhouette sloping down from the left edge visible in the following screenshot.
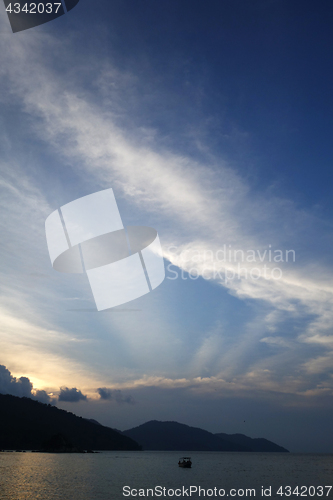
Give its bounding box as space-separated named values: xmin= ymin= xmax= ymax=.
xmin=0 ymin=394 xmax=140 ymax=452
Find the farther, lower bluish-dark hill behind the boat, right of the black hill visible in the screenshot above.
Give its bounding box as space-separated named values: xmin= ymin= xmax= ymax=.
xmin=123 ymin=420 xmax=288 ymax=452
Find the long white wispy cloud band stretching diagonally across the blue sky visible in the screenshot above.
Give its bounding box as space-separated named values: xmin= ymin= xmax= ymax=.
xmin=1 ymin=20 xmax=333 ymax=402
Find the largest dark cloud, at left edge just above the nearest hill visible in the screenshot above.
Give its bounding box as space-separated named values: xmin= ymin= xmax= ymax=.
xmin=0 ymin=365 xmax=52 ymax=403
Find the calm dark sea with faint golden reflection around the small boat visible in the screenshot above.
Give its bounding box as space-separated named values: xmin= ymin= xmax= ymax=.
xmin=0 ymin=451 xmax=333 ymax=500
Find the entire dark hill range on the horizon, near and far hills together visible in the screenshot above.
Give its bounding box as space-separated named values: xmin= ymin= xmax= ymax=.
xmin=0 ymin=394 xmax=288 ymax=453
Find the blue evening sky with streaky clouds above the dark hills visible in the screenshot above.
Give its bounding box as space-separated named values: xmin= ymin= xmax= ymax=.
xmin=0 ymin=0 xmax=333 ymax=453
